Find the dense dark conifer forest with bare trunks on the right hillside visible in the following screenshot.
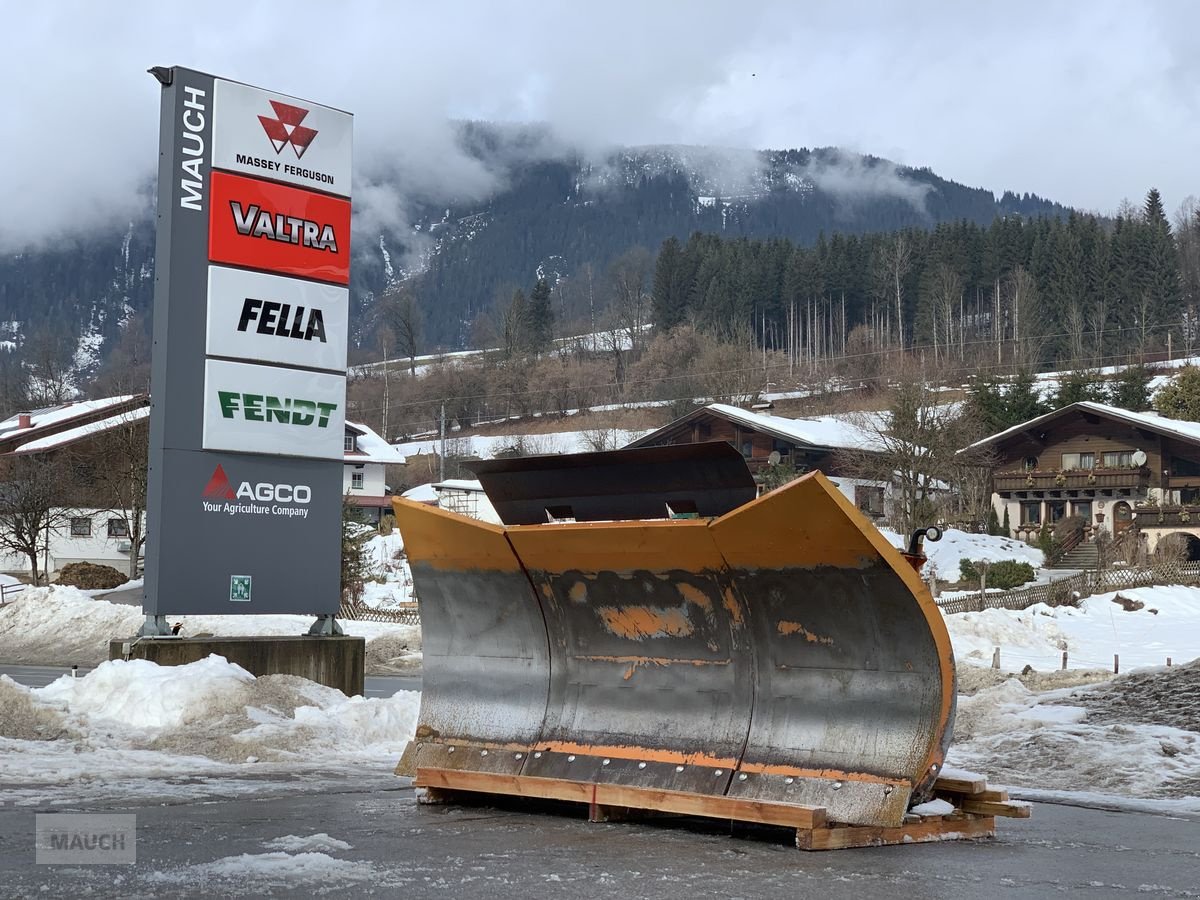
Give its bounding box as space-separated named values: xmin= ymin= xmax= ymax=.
xmin=652 ymin=190 xmax=1200 ymax=371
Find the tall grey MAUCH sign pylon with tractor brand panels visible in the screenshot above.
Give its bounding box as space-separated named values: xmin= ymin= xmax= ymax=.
xmin=144 ymin=67 xmax=354 ymax=634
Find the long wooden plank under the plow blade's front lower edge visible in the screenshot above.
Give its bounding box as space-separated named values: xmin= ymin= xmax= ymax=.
xmin=413 ymin=768 xmax=826 ymax=828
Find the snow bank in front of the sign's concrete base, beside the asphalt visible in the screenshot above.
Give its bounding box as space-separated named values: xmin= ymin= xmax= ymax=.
xmin=0 ymin=655 xmax=420 ymax=804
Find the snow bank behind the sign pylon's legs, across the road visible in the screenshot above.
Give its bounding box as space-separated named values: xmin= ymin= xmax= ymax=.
xmin=0 ymin=584 xmax=421 ymax=673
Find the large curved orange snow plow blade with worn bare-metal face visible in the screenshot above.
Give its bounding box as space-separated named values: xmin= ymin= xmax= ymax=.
xmin=394 ymin=473 xmax=955 ymax=827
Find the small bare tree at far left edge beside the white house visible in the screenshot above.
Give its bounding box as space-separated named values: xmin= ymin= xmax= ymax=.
xmin=0 ymin=454 xmax=71 ymax=584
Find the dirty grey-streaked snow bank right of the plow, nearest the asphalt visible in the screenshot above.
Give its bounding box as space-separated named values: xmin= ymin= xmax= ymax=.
xmin=949 ymin=665 xmax=1200 ymax=812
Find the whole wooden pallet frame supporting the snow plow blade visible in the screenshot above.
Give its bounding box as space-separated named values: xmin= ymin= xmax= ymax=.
xmin=413 ymin=768 xmax=1030 ymax=850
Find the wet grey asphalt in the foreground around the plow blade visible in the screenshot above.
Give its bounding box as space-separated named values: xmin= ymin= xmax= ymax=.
xmin=0 ymin=779 xmax=1200 ymax=900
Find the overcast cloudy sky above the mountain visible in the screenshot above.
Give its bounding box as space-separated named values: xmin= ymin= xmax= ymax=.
xmin=0 ymin=0 xmax=1200 ymax=248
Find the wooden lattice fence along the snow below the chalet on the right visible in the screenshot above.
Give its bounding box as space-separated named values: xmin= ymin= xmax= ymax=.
xmin=937 ymin=563 xmax=1200 ymax=613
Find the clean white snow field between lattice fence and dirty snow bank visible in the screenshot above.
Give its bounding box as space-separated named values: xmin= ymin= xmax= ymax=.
xmin=946 ymin=587 xmax=1200 ymax=672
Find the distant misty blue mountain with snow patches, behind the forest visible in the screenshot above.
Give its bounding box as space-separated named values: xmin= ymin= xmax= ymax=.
xmin=0 ymin=130 xmax=1068 ymax=376
